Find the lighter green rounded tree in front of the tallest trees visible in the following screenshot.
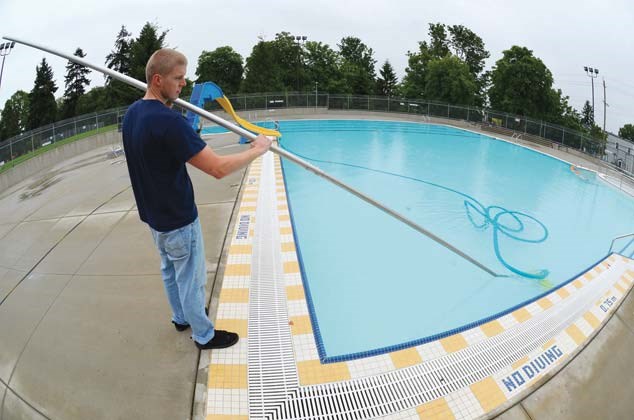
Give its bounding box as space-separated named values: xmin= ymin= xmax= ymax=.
xmin=425 ymin=55 xmax=477 ymax=105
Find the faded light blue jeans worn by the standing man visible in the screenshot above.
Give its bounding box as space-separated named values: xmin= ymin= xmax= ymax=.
xmin=150 ymin=218 xmax=214 ymax=344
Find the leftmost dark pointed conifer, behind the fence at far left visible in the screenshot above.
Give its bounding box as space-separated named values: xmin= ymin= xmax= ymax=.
xmin=28 ymin=58 xmax=57 ymax=130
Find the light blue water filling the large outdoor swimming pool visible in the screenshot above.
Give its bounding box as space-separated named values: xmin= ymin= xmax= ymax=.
xmin=280 ymin=120 xmax=634 ymax=361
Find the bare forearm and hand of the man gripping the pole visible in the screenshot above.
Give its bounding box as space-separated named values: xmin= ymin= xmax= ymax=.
xmin=188 ymin=134 xmax=271 ymax=179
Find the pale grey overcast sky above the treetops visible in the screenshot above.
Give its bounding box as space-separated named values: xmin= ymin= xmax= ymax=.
xmin=0 ymin=0 xmax=634 ymax=133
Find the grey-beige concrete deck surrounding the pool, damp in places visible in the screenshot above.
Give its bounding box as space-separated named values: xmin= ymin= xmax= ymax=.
xmin=0 ymin=112 xmax=634 ymax=420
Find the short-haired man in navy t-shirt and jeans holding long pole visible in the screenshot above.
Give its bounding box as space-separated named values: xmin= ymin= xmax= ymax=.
xmin=122 ymin=48 xmax=271 ymax=349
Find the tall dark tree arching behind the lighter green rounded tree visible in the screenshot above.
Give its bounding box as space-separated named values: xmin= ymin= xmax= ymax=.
xmin=403 ymin=23 xmax=490 ymax=105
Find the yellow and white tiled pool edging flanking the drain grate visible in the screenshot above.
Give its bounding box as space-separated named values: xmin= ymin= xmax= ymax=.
xmin=201 ymin=120 xmax=634 ymax=419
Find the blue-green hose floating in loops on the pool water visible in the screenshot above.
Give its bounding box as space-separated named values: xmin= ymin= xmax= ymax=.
xmin=279 ymin=140 xmax=549 ymax=280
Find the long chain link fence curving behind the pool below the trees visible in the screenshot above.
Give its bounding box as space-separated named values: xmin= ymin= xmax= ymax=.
xmin=0 ymin=91 xmax=631 ymax=180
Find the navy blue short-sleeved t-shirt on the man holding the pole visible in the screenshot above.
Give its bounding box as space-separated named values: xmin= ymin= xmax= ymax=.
xmin=122 ymin=99 xmax=206 ymax=232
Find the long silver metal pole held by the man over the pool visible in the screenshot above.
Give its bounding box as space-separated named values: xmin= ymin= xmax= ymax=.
xmin=3 ymin=36 xmax=503 ymax=277
